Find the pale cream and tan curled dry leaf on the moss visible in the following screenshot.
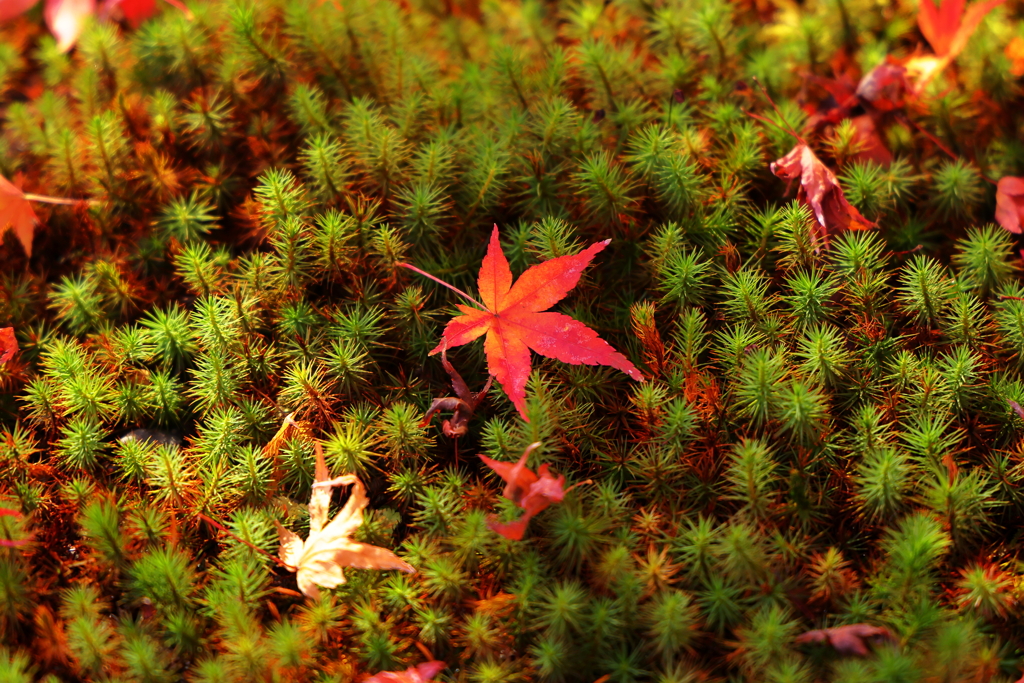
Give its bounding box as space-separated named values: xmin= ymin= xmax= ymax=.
xmin=278 ymin=432 xmax=416 ymax=598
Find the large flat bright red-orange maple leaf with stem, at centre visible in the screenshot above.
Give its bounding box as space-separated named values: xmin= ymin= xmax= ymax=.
xmin=402 ymin=225 xmax=643 ymax=421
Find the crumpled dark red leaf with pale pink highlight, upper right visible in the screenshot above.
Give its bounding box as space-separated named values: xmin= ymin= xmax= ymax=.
xmin=771 ymin=143 xmax=874 ymax=245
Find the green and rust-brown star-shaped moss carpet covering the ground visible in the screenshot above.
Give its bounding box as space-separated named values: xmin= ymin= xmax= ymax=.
xmin=0 ymin=0 xmax=1024 ymax=683
